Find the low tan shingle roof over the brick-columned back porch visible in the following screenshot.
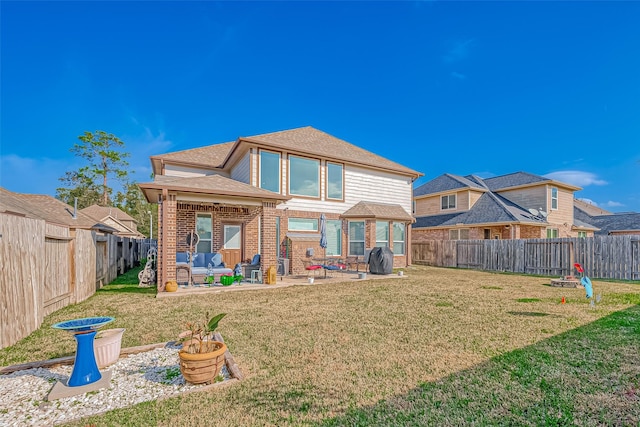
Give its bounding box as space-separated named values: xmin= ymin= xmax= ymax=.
xmin=138 ymin=175 xmax=290 ymax=200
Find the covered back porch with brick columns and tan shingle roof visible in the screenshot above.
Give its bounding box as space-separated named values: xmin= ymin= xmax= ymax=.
xmin=140 ymin=175 xmax=288 ymax=293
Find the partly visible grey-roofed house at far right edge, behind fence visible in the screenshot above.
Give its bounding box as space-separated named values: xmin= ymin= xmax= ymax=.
xmin=573 ymin=200 xmax=640 ymax=236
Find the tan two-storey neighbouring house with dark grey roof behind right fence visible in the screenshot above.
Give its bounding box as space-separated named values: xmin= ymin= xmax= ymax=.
xmin=412 ymin=172 xmax=597 ymax=242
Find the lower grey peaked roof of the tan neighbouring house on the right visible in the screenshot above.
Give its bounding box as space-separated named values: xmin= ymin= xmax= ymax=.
xmin=414 ymin=193 xmax=546 ymax=228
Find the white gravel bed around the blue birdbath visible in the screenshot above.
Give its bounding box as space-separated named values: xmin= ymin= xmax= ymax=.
xmin=0 ymin=347 xmax=231 ymax=426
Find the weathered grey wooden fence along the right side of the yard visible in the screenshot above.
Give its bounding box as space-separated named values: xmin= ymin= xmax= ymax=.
xmin=411 ymin=236 xmax=640 ymax=280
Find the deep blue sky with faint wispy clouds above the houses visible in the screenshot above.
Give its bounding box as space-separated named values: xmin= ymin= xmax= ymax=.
xmin=0 ymin=1 xmax=640 ymax=212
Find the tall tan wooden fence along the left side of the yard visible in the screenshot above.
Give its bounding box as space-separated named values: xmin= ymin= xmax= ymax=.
xmin=0 ymin=214 xmax=146 ymax=348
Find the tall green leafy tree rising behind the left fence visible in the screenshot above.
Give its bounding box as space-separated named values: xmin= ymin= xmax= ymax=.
xmin=56 ymin=130 xmax=129 ymax=208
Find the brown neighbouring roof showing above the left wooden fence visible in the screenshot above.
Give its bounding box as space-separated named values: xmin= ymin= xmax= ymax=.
xmin=0 ymin=187 xmax=116 ymax=233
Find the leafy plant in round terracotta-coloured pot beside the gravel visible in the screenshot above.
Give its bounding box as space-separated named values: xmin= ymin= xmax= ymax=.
xmin=178 ymin=313 xmax=227 ymax=384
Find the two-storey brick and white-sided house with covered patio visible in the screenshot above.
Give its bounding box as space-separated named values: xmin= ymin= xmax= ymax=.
xmin=139 ymin=127 xmax=421 ymax=289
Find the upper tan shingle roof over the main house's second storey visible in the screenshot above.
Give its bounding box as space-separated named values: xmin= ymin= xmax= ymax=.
xmin=151 ymin=126 xmax=422 ymax=178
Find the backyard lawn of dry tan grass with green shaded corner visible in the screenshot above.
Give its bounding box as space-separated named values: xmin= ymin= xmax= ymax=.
xmin=0 ymin=267 xmax=640 ymax=427
